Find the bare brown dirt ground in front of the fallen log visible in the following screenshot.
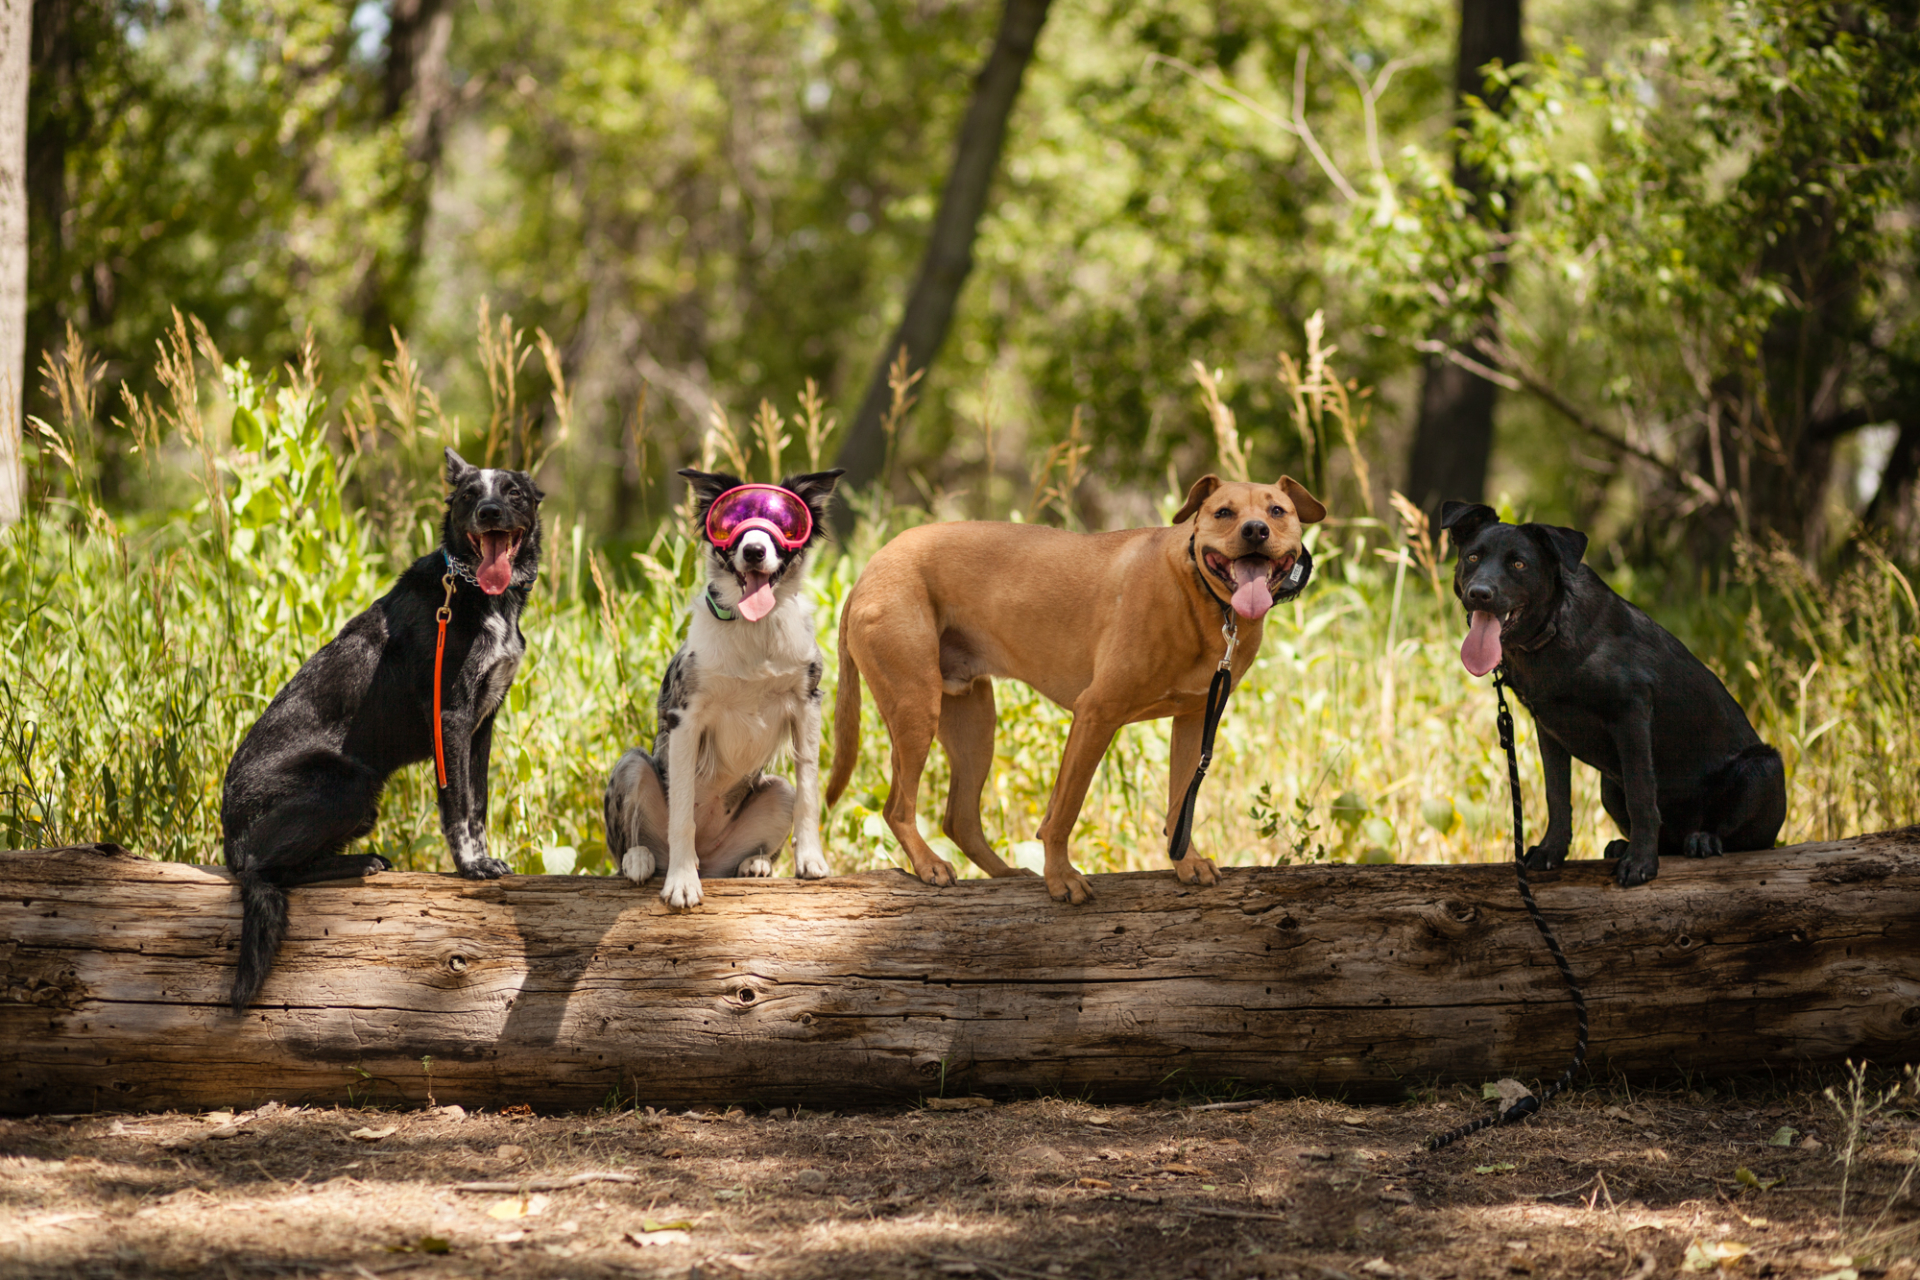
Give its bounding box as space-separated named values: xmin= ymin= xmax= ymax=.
xmin=0 ymin=1073 xmax=1920 ymax=1280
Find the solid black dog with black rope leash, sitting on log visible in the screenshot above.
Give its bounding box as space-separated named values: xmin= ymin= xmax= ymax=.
xmin=1440 ymin=503 xmax=1788 ymax=889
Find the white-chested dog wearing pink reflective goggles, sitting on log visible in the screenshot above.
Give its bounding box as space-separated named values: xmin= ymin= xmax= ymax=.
xmin=605 ymin=468 xmax=843 ymax=908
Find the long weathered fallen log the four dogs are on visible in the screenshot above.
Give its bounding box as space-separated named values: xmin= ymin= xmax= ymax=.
xmin=0 ymin=827 xmax=1920 ymax=1113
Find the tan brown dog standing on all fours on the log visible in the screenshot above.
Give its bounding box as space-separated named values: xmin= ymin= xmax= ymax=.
xmin=828 ymin=476 xmax=1327 ymax=904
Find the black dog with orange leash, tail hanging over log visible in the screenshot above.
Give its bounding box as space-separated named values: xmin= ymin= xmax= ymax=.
xmin=221 ymin=449 xmax=543 ymax=1013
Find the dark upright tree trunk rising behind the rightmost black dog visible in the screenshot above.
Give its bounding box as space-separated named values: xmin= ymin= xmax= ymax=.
xmin=1405 ymin=0 xmax=1523 ymax=514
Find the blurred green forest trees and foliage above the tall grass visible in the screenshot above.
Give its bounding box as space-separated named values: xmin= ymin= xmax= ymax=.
xmin=29 ymin=0 xmax=1920 ymax=552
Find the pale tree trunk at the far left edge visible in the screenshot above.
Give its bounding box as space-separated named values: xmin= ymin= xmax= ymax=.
xmin=0 ymin=0 xmax=33 ymax=524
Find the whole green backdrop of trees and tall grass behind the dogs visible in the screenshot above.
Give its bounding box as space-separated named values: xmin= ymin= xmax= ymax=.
xmin=0 ymin=0 xmax=1920 ymax=869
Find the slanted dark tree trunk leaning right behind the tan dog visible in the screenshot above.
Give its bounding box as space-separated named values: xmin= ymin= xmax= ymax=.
xmin=837 ymin=0 xmax=1050 ymax=510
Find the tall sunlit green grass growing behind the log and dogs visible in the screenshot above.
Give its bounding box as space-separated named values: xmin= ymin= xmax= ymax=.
xmin=0 ymin=328 xmax=1920 ymax=873
